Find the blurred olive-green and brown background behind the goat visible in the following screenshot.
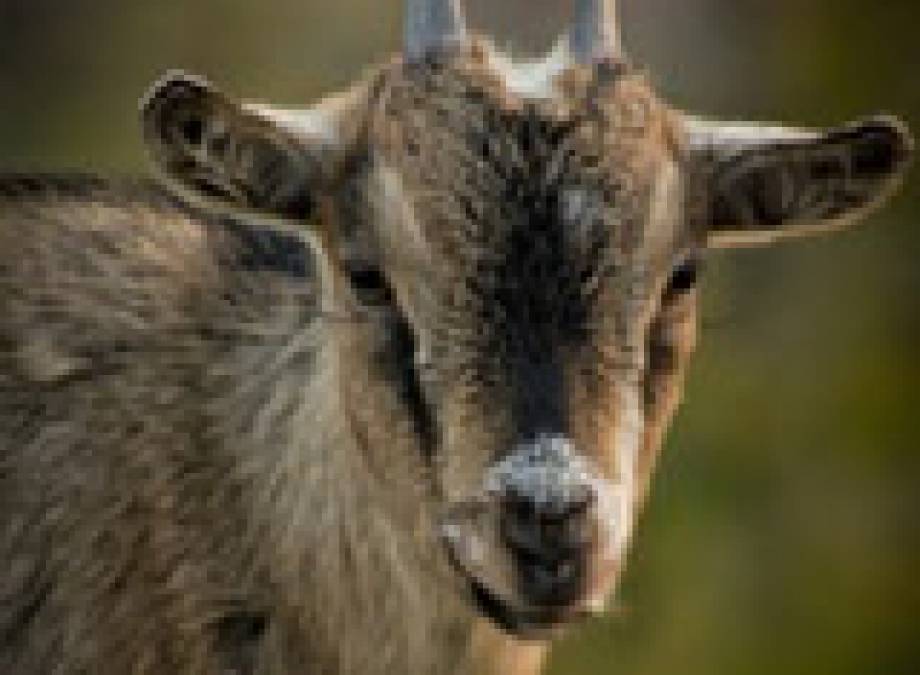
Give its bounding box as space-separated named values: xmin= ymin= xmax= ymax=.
xmin=0 ymin=0 xmax=920 ymax=675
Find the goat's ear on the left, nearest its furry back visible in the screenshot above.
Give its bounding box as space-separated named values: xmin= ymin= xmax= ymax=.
xmin=141 ymin=73 xmax=338 ymax=217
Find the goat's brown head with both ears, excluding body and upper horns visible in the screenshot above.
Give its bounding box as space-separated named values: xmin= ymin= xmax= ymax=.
xmin=144 ymin=3 xmax=909 ymax=633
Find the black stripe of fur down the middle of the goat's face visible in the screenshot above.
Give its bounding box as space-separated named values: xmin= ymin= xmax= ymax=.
xmin=458 ymin=108 xmax=606 ymax=439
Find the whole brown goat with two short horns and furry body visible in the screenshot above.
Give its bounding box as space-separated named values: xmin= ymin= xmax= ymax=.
xmin=0 ymin=0 xmax=912 ymax=675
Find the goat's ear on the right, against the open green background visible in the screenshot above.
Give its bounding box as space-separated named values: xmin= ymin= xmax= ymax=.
xmin=685 ymin=117 xmax=912 ymax=247
